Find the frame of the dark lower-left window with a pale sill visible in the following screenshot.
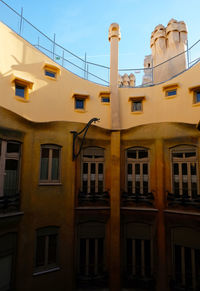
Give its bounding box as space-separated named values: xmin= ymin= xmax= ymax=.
xmin=34 ymin=226 xmax=59 ymax=275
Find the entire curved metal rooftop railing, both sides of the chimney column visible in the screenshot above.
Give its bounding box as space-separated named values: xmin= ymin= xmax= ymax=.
xmin=0 ymin=0 xmax=200 ymax=87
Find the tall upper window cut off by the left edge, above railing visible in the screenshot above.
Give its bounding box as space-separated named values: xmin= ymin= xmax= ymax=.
xmin=0 ymin=139 xmax=21 ymax=197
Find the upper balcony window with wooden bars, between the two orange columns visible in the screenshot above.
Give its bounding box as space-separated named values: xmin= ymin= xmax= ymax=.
xmin=126 ymin=148 xmax=149 ymax=194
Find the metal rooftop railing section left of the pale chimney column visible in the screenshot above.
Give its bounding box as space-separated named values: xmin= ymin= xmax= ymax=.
xmin=0 ymin=0 xmax=110 ymax=86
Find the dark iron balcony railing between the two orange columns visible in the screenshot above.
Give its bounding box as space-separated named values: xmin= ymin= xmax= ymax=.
xmin=122 ymin=192 xmax=154 ymax=206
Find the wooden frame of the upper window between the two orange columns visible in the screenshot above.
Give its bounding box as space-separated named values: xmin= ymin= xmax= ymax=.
xmin=125 ymin=147 xmax=151 ymax=195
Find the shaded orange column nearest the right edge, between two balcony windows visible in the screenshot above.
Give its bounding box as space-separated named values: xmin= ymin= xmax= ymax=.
xmin=156 ymin=140 xmax=168 ymax=291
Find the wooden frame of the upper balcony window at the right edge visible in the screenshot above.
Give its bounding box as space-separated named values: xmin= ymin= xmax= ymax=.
xmin=170 ymin=145 xmax=199 ymax=198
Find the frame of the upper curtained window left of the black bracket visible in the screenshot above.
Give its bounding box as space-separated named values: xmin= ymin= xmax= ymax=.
xmin=39 ymin=144 xmax=62 ymax=185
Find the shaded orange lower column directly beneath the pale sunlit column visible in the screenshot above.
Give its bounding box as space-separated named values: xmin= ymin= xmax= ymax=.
xmin=110 ymin=131 xmax=120 ymax=291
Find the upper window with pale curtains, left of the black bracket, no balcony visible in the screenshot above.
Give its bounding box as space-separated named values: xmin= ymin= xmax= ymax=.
xmin=40 ymin=145 xmax=61 ymax=183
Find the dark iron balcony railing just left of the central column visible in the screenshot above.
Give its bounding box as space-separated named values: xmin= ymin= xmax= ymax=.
xmin=78 ymin=191 xmax=110 ymax=206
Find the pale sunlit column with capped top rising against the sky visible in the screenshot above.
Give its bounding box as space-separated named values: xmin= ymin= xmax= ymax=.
xmin=108 ymin=23 xmax=121 ymax=129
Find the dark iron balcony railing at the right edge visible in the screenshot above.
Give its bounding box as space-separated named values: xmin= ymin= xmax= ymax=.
xmin=167 ymin=192 xmax=200 ymax=208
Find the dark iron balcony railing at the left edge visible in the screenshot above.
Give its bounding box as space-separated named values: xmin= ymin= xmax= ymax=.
xmin=0 ymin=193 xmax=20 ymax=213
